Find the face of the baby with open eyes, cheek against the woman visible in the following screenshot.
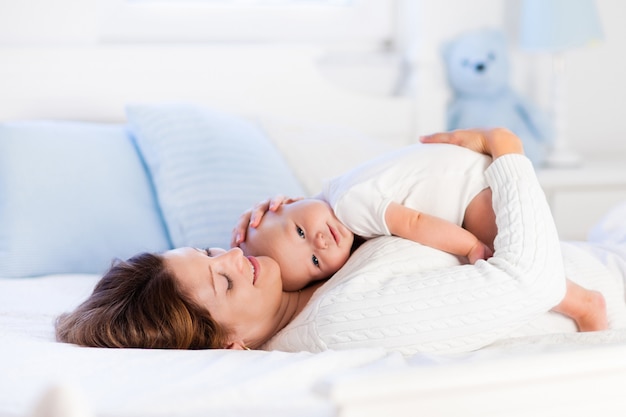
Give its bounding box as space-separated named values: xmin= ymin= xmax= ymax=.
xmin=240 ymin=198 xmax=354 ymax=291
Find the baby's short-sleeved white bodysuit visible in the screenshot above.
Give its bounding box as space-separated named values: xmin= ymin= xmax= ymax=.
xmin=321 ymin=144 xmax=491 ymax=238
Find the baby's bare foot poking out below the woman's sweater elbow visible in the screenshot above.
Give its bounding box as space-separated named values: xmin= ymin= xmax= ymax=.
xmin=552 ymin=279 xmax=609 ymax=332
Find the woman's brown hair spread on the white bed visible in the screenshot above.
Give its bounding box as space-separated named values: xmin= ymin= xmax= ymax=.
xmin=56 ymin=253 xmax=227 ymax=349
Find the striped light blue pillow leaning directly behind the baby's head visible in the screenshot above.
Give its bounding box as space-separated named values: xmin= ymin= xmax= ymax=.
xmin=126 ymin=104 xmax=304 ymax=248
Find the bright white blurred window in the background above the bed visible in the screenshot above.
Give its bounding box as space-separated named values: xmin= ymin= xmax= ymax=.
xmin=99 ymin=0 xmax=394 ymax=42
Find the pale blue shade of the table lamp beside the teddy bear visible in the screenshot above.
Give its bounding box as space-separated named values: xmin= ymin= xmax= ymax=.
xmin=519 ymin=0 xmax=602 ymax=52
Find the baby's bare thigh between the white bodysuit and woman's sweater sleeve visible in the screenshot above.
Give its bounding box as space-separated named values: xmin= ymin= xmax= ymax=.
xmin=462 ymin=188 xmax=498 ymax=250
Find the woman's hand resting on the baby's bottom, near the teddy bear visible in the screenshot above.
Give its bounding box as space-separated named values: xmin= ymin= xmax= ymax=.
xmin=420 ymin=128 xmax=524 ymax=159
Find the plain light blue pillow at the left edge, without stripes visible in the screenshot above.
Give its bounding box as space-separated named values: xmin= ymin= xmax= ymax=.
xmin=0 ymin=121 xmax=170 ymax=277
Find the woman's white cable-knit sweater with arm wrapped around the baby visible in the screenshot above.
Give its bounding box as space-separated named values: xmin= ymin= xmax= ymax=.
xmin=264 ymin=155 xmax=584 ymax=354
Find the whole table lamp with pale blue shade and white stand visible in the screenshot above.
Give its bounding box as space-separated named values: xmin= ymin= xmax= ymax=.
xmin=519 ymin=0 xmax=602 ymax=167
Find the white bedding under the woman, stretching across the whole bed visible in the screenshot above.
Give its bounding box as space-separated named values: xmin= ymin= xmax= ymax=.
xmin=0 ymin=275 xmax=626 ymax=417
